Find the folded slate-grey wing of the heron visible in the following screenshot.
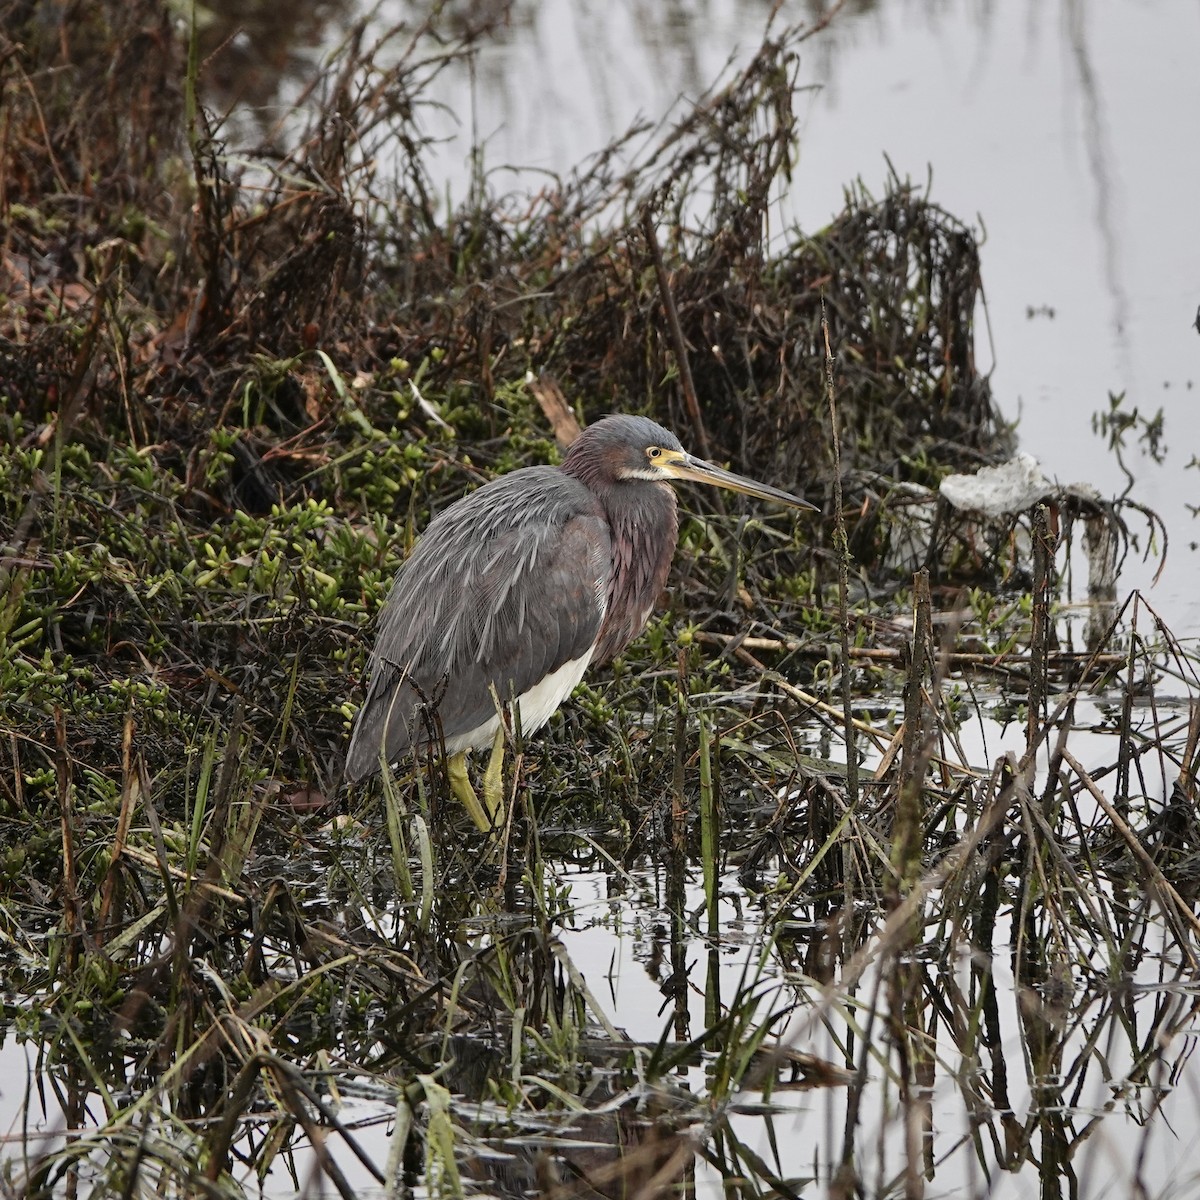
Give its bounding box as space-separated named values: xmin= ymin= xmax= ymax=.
xmin=346 ymin=467 xmax=612 ymax=781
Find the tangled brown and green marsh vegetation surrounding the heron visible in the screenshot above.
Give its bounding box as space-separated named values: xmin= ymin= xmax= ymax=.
xmin=0 ymin=2 xmax=1200 ymax=1198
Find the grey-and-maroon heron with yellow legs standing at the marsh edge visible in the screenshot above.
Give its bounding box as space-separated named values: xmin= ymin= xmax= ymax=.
xmin=346 ymin=415 xmax=814 ymax=832
